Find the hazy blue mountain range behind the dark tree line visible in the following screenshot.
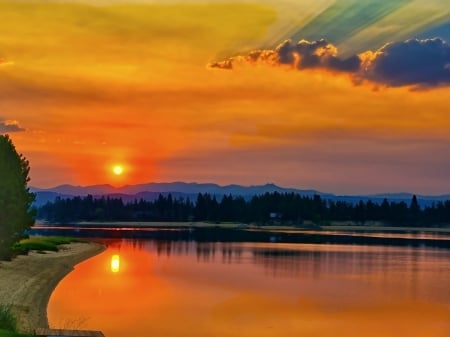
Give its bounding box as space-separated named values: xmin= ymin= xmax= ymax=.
xmin=30 ymin=182 xmax=450 ymax=207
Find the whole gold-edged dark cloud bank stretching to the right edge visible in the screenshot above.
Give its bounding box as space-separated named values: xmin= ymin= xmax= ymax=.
xmin=209 ymin=38 xmax=450 ymax=87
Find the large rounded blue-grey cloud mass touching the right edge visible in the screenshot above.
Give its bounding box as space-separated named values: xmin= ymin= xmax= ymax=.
xmin=364 ymin=38 xmax=450 ymax=86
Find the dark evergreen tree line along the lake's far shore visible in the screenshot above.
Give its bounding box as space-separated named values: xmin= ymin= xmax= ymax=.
xmin=37 ymin=192 xmax=450 ymax=226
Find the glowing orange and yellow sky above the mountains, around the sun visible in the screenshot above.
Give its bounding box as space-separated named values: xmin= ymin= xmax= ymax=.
xmin=0 ymin=0 xmax=450 ymax=194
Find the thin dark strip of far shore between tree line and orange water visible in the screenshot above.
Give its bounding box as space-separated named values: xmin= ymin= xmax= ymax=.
xmin=30 ymin=222 xmax=450 ymax=249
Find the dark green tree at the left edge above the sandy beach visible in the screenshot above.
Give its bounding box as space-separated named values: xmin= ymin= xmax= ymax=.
xmin=0 ymin=135 xmax=34 ymax=259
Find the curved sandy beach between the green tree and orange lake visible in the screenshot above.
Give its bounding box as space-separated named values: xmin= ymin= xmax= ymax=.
xmin=0 ymin=243 xmax=104 ymax=332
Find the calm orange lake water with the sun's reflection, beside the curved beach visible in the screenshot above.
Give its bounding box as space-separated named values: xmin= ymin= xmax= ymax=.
xmin=48 ymin=240 xmax=450 ymax=337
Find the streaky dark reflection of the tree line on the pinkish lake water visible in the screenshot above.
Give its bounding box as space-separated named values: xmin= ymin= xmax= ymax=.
xmin=119 ymin=240 xmax=443 ymax=297
